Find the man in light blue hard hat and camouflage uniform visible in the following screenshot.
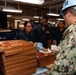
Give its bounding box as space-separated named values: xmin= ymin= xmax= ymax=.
xmin=47 ymin=0 xmax=76 ymax=75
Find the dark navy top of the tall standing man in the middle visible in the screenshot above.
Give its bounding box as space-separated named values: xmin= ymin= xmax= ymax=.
xmin=33 ymin=23 xmax=51 ymax=48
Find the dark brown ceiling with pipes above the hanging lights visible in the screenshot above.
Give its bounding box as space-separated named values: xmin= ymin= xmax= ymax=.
xmin=0 ymin=0 xmax=64 ymax=19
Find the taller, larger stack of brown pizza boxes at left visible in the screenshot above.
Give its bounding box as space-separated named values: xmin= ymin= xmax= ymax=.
xmin=0 ymin=40 xmax=37 ymax=75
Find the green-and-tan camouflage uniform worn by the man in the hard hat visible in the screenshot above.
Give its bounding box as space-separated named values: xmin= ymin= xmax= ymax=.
xmin=48 ymin=22 xmax=76 ymax=75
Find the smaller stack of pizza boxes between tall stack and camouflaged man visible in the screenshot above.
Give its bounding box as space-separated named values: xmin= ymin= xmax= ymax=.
xmin=36 ymin=52 xmax=56 ymax=67
